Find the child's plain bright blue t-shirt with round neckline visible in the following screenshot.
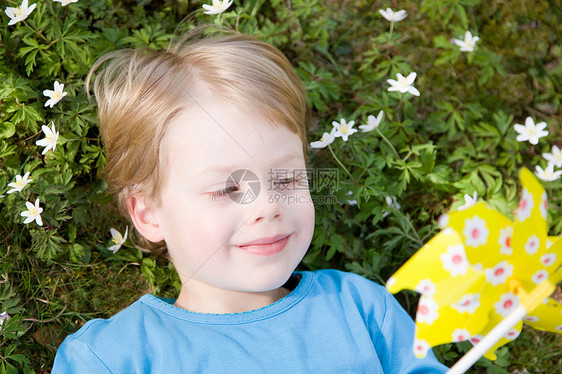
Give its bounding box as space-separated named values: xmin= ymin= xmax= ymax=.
xmin=52 ymin=270 xmax=446 ymax=374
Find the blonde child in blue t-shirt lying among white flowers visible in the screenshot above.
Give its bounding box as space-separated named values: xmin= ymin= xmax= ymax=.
xmin=53 ymin=30 xmax=445 ymax=373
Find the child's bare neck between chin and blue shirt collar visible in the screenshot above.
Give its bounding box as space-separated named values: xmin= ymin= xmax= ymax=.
xmin=174 ymin=279 xmax=290 ymax=314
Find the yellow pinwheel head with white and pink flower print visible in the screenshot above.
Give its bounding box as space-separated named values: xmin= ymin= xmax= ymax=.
xmin=386 ymin=169 xmax=562 ymax=366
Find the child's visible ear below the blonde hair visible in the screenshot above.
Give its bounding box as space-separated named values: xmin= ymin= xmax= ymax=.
xmin=126 ymin=193 xmax=164 ymax=243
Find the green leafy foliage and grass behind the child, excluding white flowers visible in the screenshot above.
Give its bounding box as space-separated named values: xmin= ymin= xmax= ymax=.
xmin=0 ymin=0 xmax=562 ymax=373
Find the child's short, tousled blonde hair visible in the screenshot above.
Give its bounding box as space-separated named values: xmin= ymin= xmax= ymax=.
xmin=86 ymin=29 xmax=310 ymax=256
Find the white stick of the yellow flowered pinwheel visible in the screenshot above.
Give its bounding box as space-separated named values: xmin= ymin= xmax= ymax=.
xmin=447 ymin=280 xmax=552 ymax=374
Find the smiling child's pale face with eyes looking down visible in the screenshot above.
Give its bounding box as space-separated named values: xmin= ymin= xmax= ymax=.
xmin=145 ymin=100 xmax=314 ymax=300
